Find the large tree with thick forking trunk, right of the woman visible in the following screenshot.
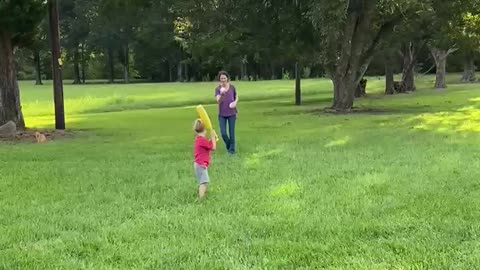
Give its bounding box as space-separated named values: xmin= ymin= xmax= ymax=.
xmin=310 ymin=0 xmax=419 ymax=111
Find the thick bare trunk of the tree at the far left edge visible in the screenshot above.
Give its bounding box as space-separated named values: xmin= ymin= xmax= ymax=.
xmin=0 ymin=29 xmax=25 ymax=129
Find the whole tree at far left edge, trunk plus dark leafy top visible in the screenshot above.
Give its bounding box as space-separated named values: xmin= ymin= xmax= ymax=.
xmin=0 ymin=0 xmax=46 ymax=128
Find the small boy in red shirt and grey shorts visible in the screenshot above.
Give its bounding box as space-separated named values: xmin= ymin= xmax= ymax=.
xmin=193 ymin=119 xmax=217 ymax=199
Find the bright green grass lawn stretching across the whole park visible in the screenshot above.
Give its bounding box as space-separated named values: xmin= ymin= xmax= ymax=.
xmin=0 ymin=75 xmax=480 ymax=269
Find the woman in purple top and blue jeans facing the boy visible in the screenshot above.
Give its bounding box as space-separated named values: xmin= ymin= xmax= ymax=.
xmin=215 ymin=71 xmax=238 ymax=154
